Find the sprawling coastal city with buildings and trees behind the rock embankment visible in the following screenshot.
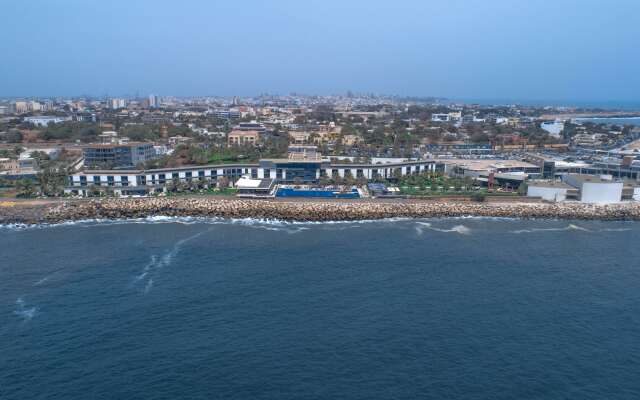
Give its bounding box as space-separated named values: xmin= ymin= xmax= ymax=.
xmin=0 ymin=92 xmax=640 ymax=209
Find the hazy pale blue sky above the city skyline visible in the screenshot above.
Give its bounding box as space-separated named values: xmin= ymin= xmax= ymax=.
xmin=0 ymin=0 xmax=640 ymax=101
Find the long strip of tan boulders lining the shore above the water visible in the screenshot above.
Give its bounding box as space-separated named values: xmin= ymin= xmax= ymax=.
xmin=0 ymin=197 xmax=640 ymax=225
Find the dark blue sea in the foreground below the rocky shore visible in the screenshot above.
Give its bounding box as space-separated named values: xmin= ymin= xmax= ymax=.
xmin=0 ymin=218 xmax=640 ymax=400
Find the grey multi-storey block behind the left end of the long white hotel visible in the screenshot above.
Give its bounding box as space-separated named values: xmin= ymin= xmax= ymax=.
xmin=83 ymin=143 xmax=157 ymax=169
